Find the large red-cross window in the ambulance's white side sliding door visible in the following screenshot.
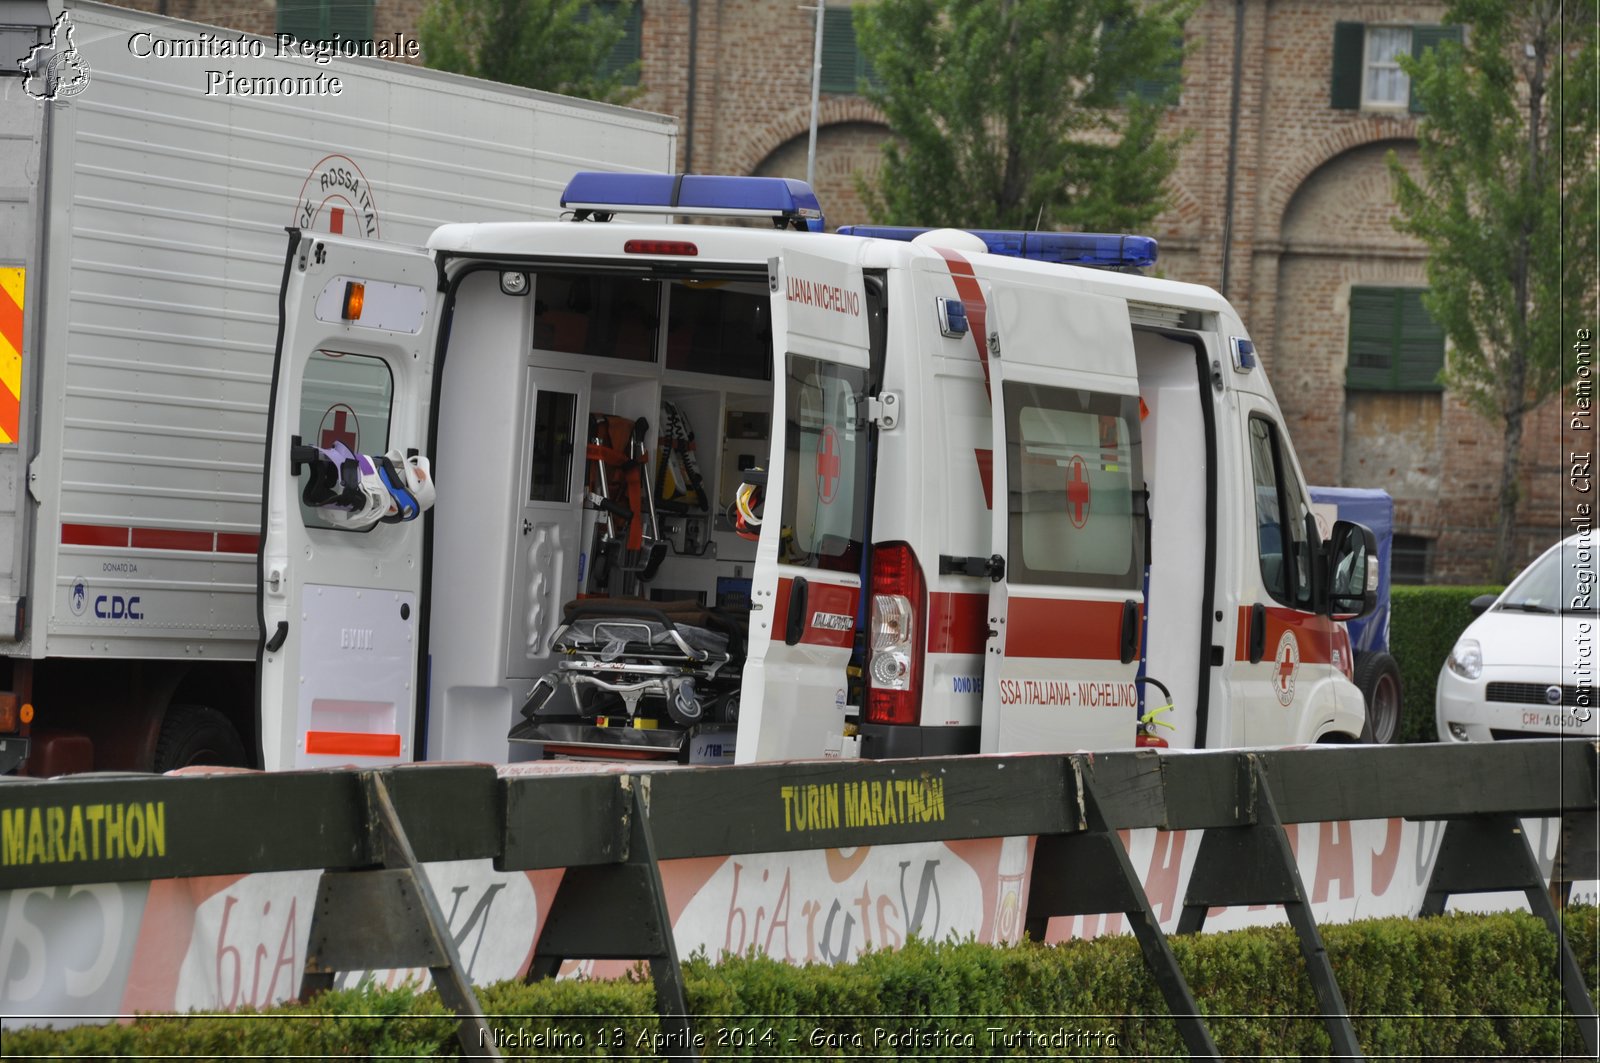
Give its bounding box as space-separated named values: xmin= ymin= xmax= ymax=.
xmin=1005 ymin=381 xmax=1144 ymax=591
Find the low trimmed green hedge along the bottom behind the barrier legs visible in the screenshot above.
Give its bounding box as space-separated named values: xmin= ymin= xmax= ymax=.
xmin=5 ymin=908 xmax=1600 ymax=1060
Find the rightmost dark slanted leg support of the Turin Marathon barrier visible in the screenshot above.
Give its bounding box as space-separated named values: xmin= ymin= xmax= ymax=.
xmin=1419 ymin=815 xmax=1600 ymax=1057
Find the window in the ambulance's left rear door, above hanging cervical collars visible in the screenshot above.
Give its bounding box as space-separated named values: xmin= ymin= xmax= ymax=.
xmin=296 ymin=351 xmax=394 ymax=528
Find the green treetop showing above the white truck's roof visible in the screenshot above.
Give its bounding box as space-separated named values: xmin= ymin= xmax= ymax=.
xmin=418 ymin=0 xmax=638 ymax=102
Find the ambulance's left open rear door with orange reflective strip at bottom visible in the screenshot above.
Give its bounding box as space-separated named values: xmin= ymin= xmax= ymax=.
xmin=259 ymin=234 xmax=442 ymax=770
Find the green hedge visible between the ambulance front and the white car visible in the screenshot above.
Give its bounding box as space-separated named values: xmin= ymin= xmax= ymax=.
xmin=1389 ymin=586 xmax=1501 ymax=741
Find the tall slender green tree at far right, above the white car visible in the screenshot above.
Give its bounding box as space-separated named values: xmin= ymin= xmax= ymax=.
xmin=1389 ymin=0 xmax=1597 ymax=583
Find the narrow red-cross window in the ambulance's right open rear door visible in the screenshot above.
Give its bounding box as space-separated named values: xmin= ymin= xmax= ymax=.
xmin=779 ymin=355 xmax=867 ymax=572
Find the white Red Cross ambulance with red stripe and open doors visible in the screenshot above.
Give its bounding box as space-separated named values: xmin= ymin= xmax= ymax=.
xmin=259 ymin=174 xmax=1376 ymax=768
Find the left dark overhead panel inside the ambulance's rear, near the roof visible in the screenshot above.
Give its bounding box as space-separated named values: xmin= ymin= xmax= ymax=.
xmin=533 ymin=272 xmax=661 ymax=362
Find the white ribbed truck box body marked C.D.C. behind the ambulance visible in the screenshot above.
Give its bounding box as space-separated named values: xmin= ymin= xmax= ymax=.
xmin=0 ymin=3 xmax=677 ymax=767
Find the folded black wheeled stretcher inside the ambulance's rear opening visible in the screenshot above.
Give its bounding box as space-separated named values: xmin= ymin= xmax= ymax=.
xmin=509 ymin=599 xmax=749 ymax=759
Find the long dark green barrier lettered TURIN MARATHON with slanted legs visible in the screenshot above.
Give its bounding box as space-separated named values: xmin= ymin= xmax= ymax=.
xmin=0 ymin=740 xmax=1600 ymax=1058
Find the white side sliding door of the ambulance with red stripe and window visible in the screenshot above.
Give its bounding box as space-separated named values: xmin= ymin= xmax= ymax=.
xmin=979 ymin=277 xmax=1146 ymax=752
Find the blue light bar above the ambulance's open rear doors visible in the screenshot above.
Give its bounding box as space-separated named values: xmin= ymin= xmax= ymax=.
xmin=562 ymin=171 xmax=822 ymax=232
